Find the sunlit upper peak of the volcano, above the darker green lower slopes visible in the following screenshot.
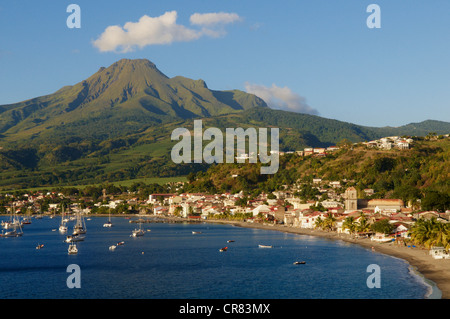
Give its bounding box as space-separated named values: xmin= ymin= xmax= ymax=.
xmin=0 ymin=59 xmax=267 ymax=141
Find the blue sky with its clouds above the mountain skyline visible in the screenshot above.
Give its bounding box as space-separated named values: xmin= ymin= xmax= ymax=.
xmin=0 ymin=0 xmax=450 ymax=127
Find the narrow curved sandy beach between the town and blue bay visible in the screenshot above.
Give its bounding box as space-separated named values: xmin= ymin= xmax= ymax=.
xmin=196 ymin=220 xmax=450 ymax=299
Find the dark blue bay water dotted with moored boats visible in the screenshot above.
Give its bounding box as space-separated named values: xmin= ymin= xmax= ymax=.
xmin=0 ymin=217 xmax=429 ymax=299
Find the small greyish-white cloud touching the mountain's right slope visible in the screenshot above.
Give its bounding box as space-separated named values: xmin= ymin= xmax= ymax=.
xmin=245 ymin=83 xmax=319 ymax=115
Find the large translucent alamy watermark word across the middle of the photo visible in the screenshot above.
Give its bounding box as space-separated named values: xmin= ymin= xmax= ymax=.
xmin=170 ymin=120 xmax=279 ymax=174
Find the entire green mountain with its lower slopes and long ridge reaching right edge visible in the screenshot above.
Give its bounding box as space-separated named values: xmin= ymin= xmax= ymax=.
xmin=0 ymin=59 xmax=450 ymax=190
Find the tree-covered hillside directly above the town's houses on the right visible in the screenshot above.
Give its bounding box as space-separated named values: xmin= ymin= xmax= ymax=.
xmin=184 ymin=138 xmax=450 ymax=211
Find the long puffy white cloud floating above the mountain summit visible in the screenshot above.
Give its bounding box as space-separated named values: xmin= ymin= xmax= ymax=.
xmin=93 ymin=11 xmax=240 ymax=53
